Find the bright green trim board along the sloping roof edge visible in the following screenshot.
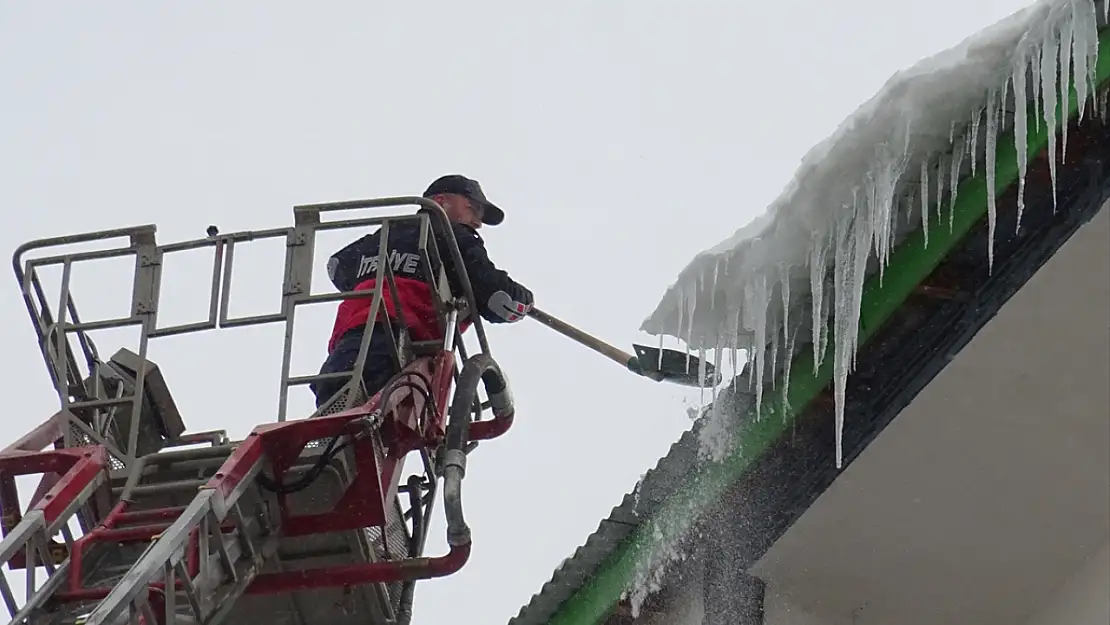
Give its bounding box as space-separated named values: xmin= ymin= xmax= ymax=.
xmin=547 ymin=23 xmax=1110 ymax=625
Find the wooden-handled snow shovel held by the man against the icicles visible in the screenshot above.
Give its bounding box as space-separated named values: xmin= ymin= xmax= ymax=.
xmin=528 ymin=308 xmax=720 ymax=387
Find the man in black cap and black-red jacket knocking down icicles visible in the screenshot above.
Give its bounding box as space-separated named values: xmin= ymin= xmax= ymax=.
xmin=311 ymin=174 xmax=533 ymax=407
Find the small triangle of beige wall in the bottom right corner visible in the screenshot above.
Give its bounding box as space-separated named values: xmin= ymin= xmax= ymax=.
xmin=1026 ymin=542 xmax=1110 ymax=625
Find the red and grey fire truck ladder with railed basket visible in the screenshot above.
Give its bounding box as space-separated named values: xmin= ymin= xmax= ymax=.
xmin=0 ymin=198 xmax=514 ymax=625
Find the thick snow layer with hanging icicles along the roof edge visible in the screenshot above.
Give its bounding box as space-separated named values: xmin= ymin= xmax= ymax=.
xmin=642 ymin=0 xmax=1110 ymax=466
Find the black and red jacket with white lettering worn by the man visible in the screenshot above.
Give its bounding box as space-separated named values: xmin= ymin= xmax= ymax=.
xmin=327 ymin=221 xmax=532 ymax=351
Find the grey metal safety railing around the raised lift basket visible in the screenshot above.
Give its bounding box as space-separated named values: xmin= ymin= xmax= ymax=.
xmin=12 ymin=196 xmax=490 ymax=464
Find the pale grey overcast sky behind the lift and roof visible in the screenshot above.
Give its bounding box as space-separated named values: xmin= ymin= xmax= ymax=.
xmin=0 ymin=0 xmax=1027 ymax=625
